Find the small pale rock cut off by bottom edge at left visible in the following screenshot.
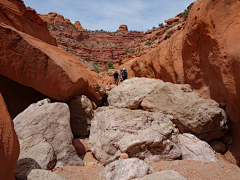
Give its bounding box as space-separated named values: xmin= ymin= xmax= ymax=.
xmin=27 ymin=169 xmax=64 ymax=180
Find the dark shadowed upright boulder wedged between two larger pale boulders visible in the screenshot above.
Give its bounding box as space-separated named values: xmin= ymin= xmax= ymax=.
xmin=68 ymin=95 xmax=93 ymax=136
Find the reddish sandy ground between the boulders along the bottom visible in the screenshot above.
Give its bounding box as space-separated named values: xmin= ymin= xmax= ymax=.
xmin=53 ymin=152 xmax=240 ymax=180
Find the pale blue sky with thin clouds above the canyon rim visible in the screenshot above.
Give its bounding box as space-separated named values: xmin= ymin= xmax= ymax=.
xmin=23 ymin=0 xmax=194 ymax=31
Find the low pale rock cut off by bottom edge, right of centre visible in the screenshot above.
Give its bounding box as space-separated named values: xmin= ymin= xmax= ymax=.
xmin=134 ymin=170 xmax=186 ymax=180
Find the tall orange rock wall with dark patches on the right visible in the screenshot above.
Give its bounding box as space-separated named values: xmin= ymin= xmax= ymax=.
xmin=122 ymin=0 xmax=240 ymax=164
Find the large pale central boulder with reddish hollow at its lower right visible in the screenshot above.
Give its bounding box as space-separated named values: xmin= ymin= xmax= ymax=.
xmin=89 ymin=107 xmax=181 ymax=165
